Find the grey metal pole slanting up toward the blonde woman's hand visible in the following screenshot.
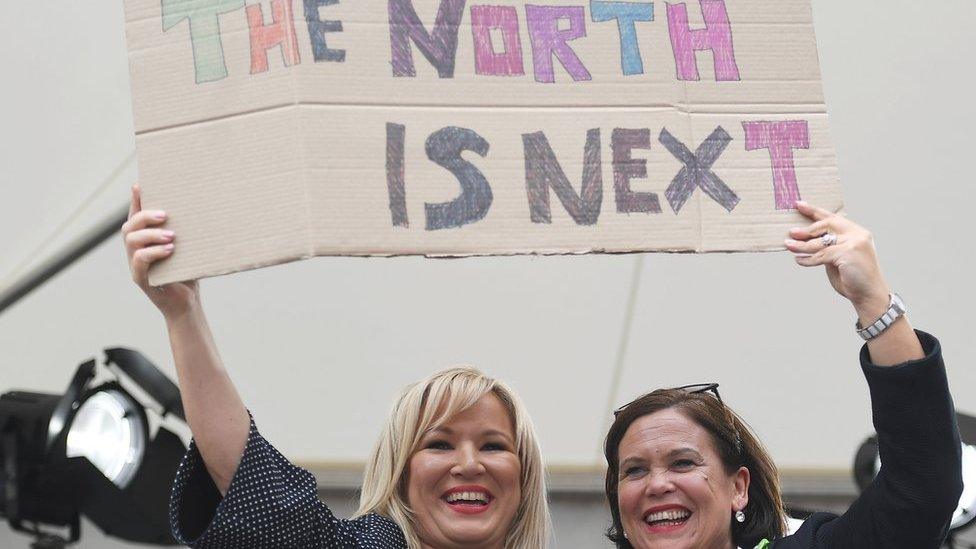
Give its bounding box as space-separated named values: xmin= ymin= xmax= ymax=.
xmin=0 ymin=205 xmax=129 ymax=313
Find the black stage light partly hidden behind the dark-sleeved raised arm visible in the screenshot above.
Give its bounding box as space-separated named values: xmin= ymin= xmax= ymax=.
xmin=854 ymin=413 xmax=976 ymax=548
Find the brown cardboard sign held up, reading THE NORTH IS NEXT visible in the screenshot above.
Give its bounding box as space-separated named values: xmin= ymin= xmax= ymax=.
xmin=125 ymin=0 xmax=841 ymax=284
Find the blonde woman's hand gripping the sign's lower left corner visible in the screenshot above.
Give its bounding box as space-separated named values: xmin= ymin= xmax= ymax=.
xmin=122 ymin=185 xmax=200 ymax=320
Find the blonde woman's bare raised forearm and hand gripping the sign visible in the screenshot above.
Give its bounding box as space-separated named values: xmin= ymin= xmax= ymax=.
xmin=122 ymin=186 xmax=250 ymax=494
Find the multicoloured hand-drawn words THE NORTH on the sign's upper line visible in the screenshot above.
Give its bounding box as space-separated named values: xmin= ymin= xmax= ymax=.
xmin=162 ymin=0 xmax=740 ymax=83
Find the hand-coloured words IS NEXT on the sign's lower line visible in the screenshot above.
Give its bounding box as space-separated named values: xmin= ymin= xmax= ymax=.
xmin=386 ymin=120 xmax=810 ymax=230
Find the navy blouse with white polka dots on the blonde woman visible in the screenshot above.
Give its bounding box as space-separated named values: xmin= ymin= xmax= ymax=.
xmin=169 ymin=418 xmax=407 ymax=549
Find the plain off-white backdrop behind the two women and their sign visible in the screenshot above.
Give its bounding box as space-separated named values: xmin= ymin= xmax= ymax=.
xmin=0 ymin=0 xmax=976 ymax=540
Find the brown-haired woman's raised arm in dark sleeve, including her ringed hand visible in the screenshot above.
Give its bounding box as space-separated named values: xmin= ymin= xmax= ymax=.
xmin=773 ymin=203 xmax=962 ymax=549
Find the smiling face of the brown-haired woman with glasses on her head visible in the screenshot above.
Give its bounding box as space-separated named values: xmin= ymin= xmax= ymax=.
xmin=617 ymin=408 xmax=749 ymax=549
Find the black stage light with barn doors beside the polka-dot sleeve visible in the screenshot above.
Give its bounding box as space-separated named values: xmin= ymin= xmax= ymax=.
xmin=0 ymin=348 xmax=186 ymax=549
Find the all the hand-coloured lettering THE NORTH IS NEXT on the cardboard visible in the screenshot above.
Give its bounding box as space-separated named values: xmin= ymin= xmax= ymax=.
xmin=162 ymin=0 xmax=810 ymax=230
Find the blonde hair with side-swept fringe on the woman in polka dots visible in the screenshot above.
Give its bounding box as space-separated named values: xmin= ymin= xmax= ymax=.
xmin=356 ymin=367 xmax=551 ymax=549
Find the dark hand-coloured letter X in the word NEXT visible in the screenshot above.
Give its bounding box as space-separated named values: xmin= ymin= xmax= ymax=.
xmin=658 ymin=126 xmax=739 ymax=213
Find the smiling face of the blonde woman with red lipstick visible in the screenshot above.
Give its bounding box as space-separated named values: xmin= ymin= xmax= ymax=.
xmin=407 ymin=393 xmax=522 ymax=549
